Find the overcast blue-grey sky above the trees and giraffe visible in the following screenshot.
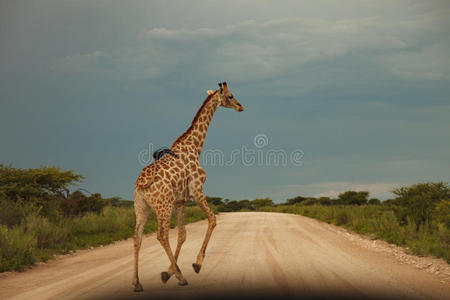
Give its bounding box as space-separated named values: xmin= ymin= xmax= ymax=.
xmin=0 ymin=0 xmax=450 ymax=201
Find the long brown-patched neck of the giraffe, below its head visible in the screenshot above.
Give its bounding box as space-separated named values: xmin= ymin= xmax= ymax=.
xmin=171 ymin=93 xmax=219 ymax=159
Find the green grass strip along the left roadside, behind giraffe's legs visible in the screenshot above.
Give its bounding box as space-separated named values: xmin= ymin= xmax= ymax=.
xmin=0 ymin=206 xmax=212 ymax=272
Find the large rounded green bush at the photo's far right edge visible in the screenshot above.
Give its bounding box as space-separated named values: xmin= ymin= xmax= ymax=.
xmin=392 ymin=181 xmax=450 ymax=229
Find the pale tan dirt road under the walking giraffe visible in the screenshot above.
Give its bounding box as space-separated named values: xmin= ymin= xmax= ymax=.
xmin=0 ymin=213 xmax=450 ymax=299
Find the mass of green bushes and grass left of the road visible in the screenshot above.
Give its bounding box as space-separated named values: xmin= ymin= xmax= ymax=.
xmin=0 ymin=164 xmax=217 ymax=272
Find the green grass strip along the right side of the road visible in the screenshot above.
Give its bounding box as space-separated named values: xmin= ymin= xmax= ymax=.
xmin=259 ymin=205 xmax=450 ymax=263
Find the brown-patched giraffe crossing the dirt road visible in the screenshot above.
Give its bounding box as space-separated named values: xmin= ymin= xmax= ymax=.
xmin=132 ymin=82 xmax=244 ymax=292
